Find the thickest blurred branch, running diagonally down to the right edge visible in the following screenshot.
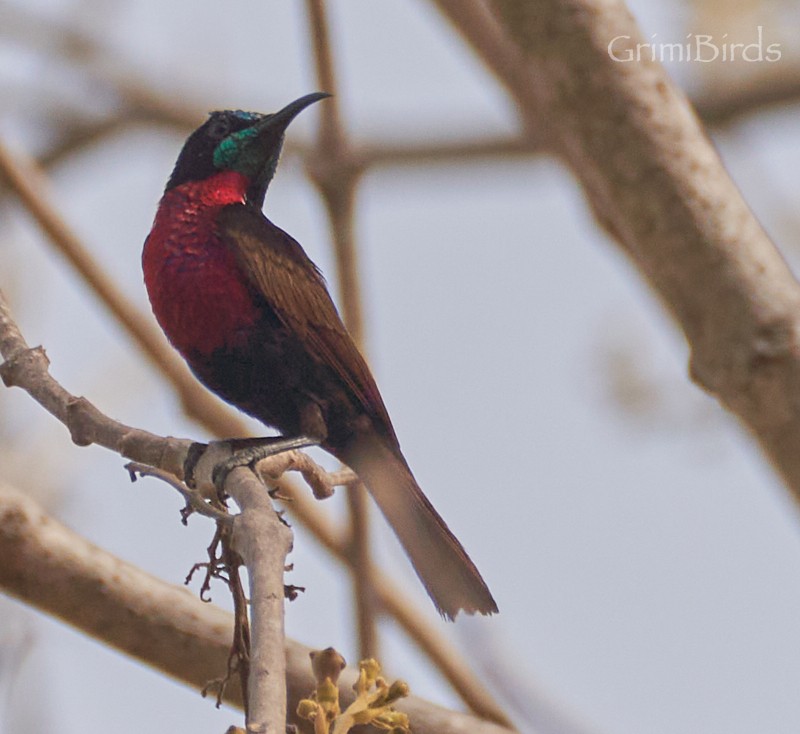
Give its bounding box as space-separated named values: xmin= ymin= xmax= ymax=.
xmin=434 ymin=0 xmax=800 ymax=497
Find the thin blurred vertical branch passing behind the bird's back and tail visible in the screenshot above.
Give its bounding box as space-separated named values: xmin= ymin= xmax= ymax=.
xmin=306 ymin=0 xmax=380 ymax=660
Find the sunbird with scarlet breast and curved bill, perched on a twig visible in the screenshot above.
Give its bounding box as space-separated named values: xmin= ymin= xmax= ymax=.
xmin=142 ymin=92 xmax=497 ymax=620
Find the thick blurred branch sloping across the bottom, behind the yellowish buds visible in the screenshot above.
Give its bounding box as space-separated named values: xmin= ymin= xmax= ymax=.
xmin=0 ymin=486 xmax=509 ymax=734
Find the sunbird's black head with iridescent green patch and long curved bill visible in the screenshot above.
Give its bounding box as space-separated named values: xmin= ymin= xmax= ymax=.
xmin=167 ymin=92 xmax=330 ymax=206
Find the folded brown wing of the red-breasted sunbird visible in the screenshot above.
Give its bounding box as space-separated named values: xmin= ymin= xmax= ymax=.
xmin=218 ymin=205 xmax=397 ymax=443
